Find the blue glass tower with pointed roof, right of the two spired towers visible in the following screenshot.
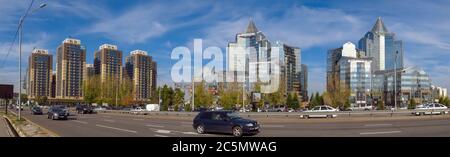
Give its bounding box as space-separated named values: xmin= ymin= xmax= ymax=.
xmin=358 ymin=18 xmax=403 ymax=71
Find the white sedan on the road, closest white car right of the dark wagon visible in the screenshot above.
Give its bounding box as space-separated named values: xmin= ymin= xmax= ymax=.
xmin=300 ymin=105 xmax=339 ymax=119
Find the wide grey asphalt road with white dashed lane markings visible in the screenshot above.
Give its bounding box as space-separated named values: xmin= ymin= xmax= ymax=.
xmin=12 ymin=109 xmax=450 ymax=137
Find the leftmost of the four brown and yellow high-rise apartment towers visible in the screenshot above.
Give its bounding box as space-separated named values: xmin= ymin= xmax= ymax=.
xmin=27 ymin=49 xmax=53 ymax=99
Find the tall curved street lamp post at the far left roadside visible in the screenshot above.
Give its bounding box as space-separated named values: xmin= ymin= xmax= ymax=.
xmin=17 ymin=0 xmax=47 ymax=120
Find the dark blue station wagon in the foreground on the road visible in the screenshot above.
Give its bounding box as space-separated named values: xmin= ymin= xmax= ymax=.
xmin=192 ymin=111 xmax=259 ymax=137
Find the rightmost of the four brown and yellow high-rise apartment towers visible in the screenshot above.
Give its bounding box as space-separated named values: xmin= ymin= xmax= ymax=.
xmin=125 ymin=50 xmax=157 ymax=101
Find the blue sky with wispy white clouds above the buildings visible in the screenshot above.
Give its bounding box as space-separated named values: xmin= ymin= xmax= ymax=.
xmin=0 ymin=0 xmax=450 ymax=96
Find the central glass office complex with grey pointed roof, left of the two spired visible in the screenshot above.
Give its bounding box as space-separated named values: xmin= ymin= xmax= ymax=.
xmin=227 ymin=20 xmax=303 ymax=99
